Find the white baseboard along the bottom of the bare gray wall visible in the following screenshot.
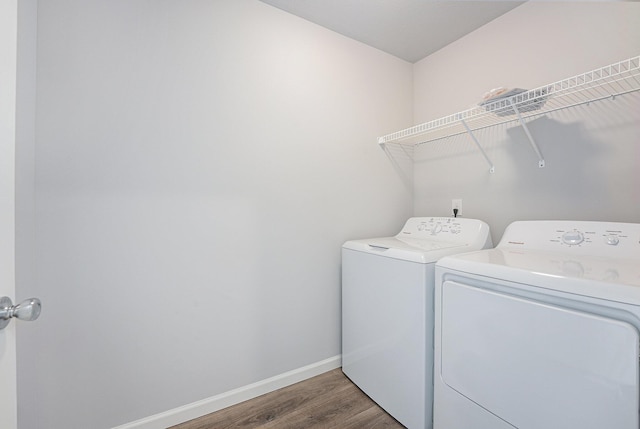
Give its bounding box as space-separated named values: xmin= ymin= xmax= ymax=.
xmin=113 ymin=355 xmax=342 ymax=429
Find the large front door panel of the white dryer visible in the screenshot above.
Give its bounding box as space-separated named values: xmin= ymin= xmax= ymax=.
xmin=440 ymin=281 xmax=638 ymax=429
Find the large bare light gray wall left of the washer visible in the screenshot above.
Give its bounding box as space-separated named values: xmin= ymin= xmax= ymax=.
xmin=19 ymin=0 xmax=412 ymax=429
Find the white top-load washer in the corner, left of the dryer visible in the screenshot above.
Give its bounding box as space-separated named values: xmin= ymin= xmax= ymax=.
xmin=342 ymin=217 xmax=492 ymax=429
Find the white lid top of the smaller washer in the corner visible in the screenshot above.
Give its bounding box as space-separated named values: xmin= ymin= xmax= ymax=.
xmin=342 ymin=237 xmax=473 ymax=264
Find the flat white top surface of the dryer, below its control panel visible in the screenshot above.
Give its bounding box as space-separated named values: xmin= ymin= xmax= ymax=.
xmin=437 ymin=247 xmax=640 ymax=305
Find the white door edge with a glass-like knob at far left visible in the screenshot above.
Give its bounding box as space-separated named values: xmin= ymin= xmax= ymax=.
xmin=0 ymin=0 xmax=18 ymax=429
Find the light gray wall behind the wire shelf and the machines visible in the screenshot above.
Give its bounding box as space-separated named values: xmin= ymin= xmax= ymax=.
xmin=414 ymin=2 xmax=640 ymax=243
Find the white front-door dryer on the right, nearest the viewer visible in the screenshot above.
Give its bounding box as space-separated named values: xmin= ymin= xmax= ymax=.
xmin=434 ymin=221 xmax=640 ymax=429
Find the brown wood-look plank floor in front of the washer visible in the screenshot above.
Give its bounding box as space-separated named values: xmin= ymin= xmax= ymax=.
xmin=170 ymin=368 xmax=404 ymax=429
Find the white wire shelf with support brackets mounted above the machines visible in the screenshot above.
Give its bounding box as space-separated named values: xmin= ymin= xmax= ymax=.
xmin=378 ymin=56 xmax=640 ymax=173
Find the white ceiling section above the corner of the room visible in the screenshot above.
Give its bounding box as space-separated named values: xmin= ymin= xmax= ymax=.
xmin=261 ymin=0 xmax=523 ymax=63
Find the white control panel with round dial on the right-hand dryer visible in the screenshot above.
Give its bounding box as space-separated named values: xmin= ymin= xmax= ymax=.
xmin=498 ymin=221 xmax=640 ymax=258
